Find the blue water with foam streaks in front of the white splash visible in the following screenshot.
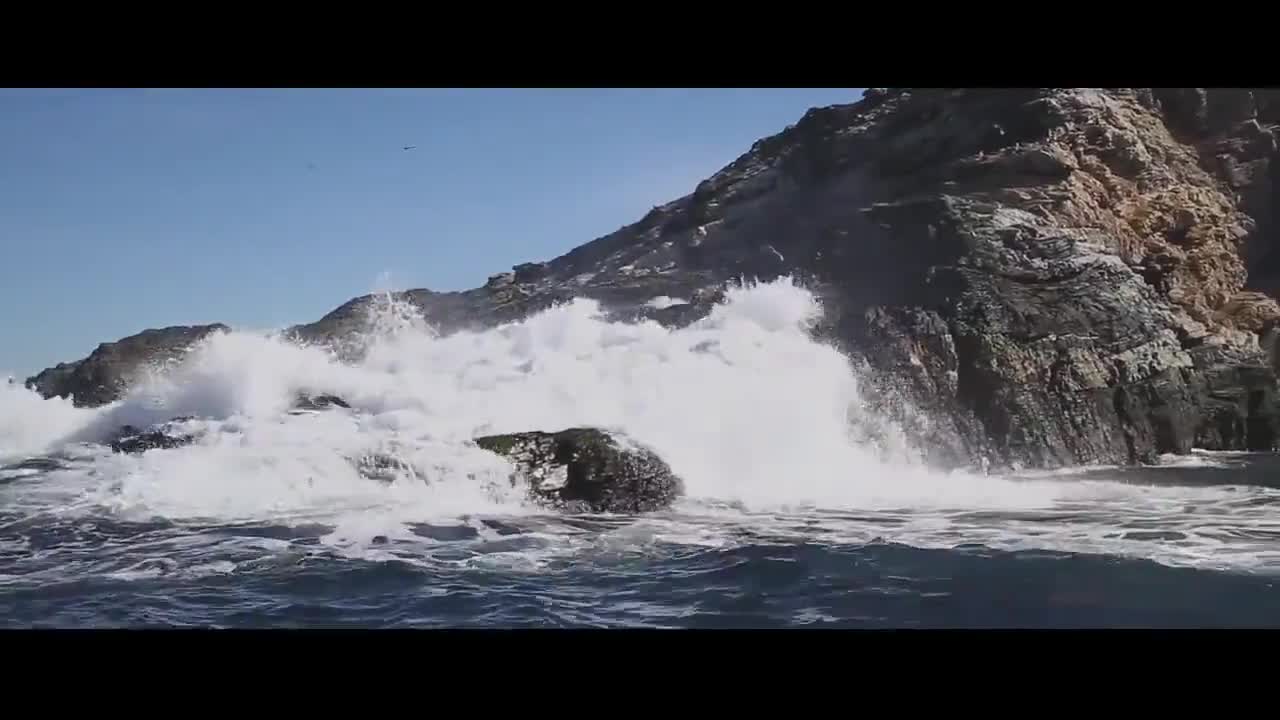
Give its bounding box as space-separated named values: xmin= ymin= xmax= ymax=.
xmin=0 ymin=456 xmax=1280 ymax=628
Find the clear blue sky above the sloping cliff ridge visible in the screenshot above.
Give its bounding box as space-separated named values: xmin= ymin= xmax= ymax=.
xmin=0 ymin=88 xmax=861 ymax=378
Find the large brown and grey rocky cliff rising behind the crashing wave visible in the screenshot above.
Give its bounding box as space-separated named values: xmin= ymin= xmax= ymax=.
xmin=28 ymin=88 xmax=1280 ymax=466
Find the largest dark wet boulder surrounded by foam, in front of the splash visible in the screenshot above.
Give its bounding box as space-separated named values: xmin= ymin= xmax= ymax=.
xmin=475 ymin=428 xmax=684 ymax=512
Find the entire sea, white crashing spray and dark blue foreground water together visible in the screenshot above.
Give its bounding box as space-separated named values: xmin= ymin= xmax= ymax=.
xmin=0 ymin=281 xmax=1280 ymax=628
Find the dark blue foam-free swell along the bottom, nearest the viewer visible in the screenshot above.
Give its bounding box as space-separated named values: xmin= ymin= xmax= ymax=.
xmin=10 ymin=530 xmax=1280 ymax=628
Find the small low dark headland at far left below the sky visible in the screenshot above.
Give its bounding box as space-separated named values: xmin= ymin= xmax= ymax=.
xmin=27 ymin=323 xmax=230 ymax=407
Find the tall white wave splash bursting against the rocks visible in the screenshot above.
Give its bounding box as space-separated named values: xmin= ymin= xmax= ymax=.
xmin=0 ymin=281 xmax=988 ymax=516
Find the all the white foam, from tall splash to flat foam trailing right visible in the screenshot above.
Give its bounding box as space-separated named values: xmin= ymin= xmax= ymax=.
xmin=0 ymin=275 xmax=1276 ymax=566
